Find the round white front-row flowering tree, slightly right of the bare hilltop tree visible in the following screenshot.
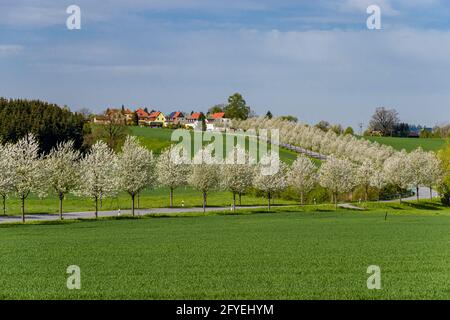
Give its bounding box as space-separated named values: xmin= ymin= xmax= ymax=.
xmin=383 ymin=150 xmax=415 ymax=202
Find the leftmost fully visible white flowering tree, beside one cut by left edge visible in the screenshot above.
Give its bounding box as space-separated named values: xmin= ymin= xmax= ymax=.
xmin=9 ymin=134 xmax=45 ymax=222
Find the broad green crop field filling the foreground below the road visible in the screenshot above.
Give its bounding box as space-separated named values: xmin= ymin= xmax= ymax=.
xmin=0 ymin=203 xmax=450 ymax=299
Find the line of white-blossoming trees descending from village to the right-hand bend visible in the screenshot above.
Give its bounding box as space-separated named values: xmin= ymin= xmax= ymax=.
xmin=233 ymin=117 xmax=444 ymax=205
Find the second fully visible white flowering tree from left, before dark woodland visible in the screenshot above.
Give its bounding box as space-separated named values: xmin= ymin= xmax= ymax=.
xmin=44 ymin=141 xmax=80 ymax=220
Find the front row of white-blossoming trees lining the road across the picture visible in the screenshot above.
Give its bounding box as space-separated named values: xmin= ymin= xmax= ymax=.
xmin=0 ymin=135 xmax=443 ymax=221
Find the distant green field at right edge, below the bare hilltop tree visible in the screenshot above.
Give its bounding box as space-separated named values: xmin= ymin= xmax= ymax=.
xmin=364 ymin=137 xmax=447 ymax=152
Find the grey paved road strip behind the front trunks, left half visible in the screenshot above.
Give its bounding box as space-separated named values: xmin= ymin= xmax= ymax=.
xmin=0 ymin=206 xmax=264 ymax=223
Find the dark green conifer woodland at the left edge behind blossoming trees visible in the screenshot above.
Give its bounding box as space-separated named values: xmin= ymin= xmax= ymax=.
xmin=0 ymin=98 xmax=86 ymax=153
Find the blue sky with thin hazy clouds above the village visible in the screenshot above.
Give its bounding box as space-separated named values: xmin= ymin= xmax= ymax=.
xmin=0 ymin=0 xmax=450 ymax=127
